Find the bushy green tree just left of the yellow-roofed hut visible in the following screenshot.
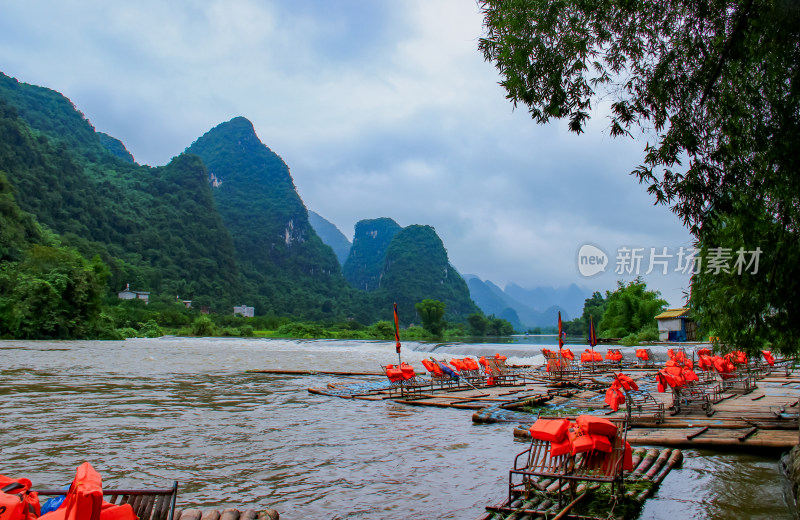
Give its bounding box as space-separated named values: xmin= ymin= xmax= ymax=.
xmin=596 ymin=278 xmax=667 ymax=338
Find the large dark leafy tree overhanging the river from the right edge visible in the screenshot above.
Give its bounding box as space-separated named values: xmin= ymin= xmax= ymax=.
xmin=479 ymin=0 xmax=800 ymax=352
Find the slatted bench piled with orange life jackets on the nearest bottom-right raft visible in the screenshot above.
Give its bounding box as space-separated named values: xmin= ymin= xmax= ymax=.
xmin=500 ymin=415 xmax=633 ymax=515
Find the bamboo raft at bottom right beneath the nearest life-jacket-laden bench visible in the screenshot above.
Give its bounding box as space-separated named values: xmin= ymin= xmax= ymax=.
xmin=480 ymin=448 xmax=683 ymax=520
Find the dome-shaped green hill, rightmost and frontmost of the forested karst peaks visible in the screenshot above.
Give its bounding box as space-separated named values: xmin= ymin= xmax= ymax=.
xmin=379 ymin=225 xmax=480 ymax=323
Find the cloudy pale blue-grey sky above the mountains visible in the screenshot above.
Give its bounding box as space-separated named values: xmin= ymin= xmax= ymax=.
xmin=0 ymin=0 xmax=691 ymax=306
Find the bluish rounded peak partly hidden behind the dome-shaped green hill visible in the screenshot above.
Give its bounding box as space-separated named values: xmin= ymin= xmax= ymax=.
xmin=342 ymin=217 xmax=402 ymax=291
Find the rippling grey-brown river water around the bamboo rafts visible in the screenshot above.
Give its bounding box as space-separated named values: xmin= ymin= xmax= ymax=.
xmin=0 ymin=337 xmax=792 ymax=520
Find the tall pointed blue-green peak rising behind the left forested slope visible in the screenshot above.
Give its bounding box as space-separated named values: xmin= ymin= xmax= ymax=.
xmin=186 ymin=117 xmax=349 ymax=318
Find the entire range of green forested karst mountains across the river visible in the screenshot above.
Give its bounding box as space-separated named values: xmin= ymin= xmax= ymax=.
xmin=0 ymin=73 xmax=478 ymax=338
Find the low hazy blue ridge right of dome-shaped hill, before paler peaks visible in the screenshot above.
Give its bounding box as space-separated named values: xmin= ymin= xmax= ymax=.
xmin=466 ymin=275 xmax=572 ymax=330
